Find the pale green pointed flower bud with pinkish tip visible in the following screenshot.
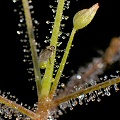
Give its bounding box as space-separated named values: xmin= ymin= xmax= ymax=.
xmin=73 ymin=3 xmax=99 ymax=30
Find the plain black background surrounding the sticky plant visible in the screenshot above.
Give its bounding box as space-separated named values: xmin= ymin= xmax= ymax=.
xmin=0 ymin=0 xmax=120 ymax=120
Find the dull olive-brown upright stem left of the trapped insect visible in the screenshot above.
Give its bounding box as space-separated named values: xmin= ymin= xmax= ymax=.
xmin=22 ymin=0 xmax=41 ymax=97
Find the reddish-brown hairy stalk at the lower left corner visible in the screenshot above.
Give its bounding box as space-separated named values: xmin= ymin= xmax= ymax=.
xmin=0 ymin=96 xmax=39 ymax=120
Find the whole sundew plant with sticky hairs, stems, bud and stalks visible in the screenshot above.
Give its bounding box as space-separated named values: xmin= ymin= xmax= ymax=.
xmin=0 ymin=0 xmax=120 ymax=120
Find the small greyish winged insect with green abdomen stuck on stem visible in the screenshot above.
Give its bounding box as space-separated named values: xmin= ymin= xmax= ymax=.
xmin=38 ymin=45 xmax=55 ymax=69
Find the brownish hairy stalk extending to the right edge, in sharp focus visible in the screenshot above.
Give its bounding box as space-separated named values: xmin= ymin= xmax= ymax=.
xmin=53 ymin=77 xmax=120 ymax=106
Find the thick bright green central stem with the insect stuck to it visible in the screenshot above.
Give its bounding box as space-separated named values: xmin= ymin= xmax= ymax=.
xmin=41 ymin=0 xmax=65 ymax=97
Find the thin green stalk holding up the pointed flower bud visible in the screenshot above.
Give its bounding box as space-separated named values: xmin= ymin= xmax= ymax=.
xmin=50 ymin=28 xmax=76 ymax=97
